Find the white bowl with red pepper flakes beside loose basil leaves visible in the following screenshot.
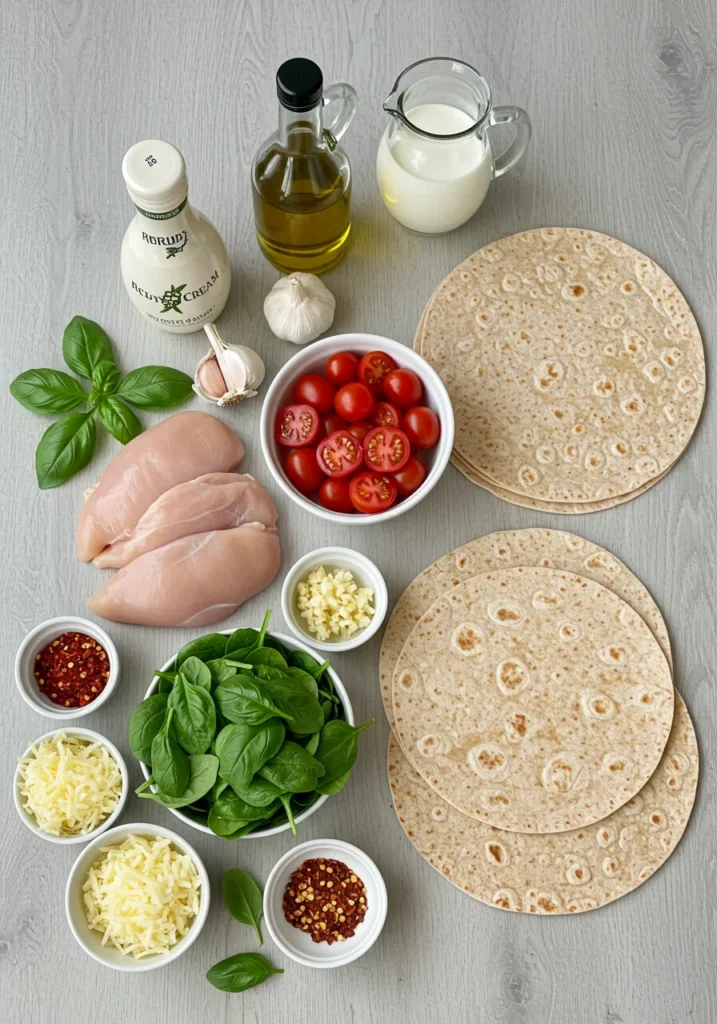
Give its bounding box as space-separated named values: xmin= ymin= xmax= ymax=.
xmin=264 ymin=839 xmax=387 ymax=968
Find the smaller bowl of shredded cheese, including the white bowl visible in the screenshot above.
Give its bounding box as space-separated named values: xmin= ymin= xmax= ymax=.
xmin=13 ymin=729 xmax=129 ymax=843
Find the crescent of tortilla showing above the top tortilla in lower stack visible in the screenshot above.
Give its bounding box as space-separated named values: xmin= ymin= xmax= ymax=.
xmin=379 ymin=527 xmax=672 ymax=728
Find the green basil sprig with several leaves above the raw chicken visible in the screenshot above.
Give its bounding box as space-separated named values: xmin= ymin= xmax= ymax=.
xmin=10 ymin=316 xmax=192 ymax=489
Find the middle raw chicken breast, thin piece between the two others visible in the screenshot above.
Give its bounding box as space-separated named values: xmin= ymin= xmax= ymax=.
xmin=93 ymin=473 xmax=278 ymax=569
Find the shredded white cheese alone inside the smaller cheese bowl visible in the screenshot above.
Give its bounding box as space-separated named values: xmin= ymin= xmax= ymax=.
xmin=19 ymin=732 xmax=122 ymax=836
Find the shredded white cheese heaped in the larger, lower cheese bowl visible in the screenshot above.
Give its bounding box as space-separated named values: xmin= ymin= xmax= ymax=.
xmin=82 ymin=836 xmax=202 ymax=959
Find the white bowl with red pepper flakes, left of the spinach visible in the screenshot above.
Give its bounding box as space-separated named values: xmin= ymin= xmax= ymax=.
xmin=15 ymin=615 xmax=120 ymax=719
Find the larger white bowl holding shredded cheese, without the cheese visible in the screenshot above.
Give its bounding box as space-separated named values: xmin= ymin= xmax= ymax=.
xmin=65 ymin=822 xmax=211 ymax=973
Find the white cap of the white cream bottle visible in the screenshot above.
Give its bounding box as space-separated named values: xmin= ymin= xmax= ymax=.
xmin=122 ymin=139 xmax=187 ymax=220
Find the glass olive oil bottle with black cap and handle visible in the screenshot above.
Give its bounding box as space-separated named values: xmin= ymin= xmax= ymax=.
xmin=252 ymin=57 xmax=356 ymax=273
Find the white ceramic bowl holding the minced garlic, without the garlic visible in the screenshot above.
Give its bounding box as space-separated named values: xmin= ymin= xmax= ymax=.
xmin=282 ymin=548 xmax=388 ymax=652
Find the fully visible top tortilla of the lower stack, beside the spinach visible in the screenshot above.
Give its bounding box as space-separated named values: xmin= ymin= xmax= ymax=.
xmin=392 ymin=567 xmax=674 ymax=833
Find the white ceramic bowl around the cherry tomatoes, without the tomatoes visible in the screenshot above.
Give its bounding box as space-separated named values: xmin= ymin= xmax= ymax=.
xmin=261 ymin=334 xmax=455 ymax=526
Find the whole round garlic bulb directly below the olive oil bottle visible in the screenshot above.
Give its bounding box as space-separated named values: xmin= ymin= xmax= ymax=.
xmin=264 ymin=271 xmax=336 ymax=345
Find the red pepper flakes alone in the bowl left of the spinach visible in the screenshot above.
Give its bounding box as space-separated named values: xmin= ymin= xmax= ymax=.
xmin=35 ymin=633 xmax=110 ymax=708
